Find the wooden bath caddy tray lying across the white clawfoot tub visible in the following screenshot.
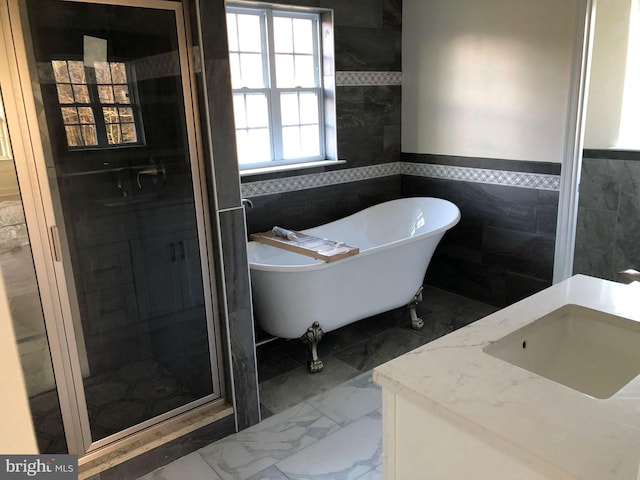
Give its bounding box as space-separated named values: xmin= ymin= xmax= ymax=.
xmin=250 ymin=231 xmax=360 ymax=262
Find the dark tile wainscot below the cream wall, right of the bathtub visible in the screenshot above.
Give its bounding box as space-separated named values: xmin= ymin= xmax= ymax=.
xmin=402 ymin=154 xmax=560 ymax=306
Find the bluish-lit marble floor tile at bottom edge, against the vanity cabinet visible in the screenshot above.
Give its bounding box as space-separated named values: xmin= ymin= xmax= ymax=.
xmin=276 ymin=412 xmax=382 ymax=480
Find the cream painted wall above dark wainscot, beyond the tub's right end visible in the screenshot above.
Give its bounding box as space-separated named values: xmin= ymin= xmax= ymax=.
xmin=402 ymin=0 xmax=583 ymax=163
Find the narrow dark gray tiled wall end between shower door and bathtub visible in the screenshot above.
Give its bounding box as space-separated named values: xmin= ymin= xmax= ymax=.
xmin=192 ymin=0 xmax=259 ymax=428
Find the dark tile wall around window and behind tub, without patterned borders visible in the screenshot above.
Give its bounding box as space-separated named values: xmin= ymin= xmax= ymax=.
xmin=242 ymin=0 xmax=402 ymax=233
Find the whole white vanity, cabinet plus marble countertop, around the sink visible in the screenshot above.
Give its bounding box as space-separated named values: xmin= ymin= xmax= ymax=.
xmin=373 ymin=275 xmax=640 ymax=480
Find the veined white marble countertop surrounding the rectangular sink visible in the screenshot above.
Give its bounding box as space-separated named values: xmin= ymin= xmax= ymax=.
xmin=373 ymin=275 xmax=640 ymax=480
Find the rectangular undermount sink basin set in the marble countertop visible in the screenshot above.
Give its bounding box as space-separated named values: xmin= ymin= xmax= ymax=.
xmin=483 ymin=305 xmax=640 ymax=399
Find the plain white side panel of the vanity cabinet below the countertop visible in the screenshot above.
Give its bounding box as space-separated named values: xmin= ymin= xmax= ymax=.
xmin=383 ymin=388 xmax=568 ymax=480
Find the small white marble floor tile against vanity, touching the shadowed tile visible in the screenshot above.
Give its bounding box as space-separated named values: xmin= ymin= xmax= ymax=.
xmin=307 ymin=372 xmax=382 ymax=425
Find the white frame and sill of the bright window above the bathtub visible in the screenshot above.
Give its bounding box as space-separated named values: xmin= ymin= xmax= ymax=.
xmin=227 ymin=2 xmax=336 ymax=173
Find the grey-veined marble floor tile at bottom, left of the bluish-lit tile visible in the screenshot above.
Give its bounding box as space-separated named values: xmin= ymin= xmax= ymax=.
xmin=199 ymin=403 xmax=340 ymax=480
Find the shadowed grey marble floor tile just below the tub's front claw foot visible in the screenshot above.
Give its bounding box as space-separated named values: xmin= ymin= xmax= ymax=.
xmin=260 ymin=356 xmax=361 ymax=413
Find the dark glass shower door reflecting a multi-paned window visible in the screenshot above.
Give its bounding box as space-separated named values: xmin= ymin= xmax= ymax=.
xmin=15 ymin=0 xmax=220 ymax=450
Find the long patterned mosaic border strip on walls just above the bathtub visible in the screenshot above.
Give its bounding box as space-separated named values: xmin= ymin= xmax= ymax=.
xmin=241 ymin=162 xmax=560 ymax=198
